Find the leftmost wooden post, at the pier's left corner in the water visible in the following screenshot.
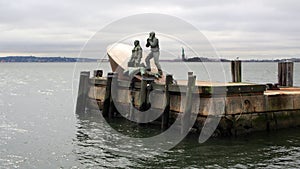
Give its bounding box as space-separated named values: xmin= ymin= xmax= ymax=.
xmin=76 ymin=71 xmax=90 ymax=114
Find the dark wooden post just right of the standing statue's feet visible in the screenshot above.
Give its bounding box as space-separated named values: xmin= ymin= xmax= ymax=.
xmin=161 ymin=74 xmax=173 ymax=130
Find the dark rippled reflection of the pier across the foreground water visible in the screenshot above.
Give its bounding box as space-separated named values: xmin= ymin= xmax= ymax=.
xmin=75 ymin=109 xmax=300 ymax=168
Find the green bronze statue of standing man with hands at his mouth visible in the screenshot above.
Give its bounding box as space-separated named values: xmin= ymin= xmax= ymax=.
xmin=145 ymin=32 xmax=163 ymax=75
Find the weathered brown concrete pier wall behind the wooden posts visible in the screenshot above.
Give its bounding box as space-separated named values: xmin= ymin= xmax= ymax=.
xmin=84 ymin=77 xmax=300 ymax=136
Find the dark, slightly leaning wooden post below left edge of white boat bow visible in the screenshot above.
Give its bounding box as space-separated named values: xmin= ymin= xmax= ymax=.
xmin=102 ymin=72 xmax=113 ymax=117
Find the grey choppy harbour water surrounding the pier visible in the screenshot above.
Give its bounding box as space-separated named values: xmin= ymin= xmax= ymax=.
xmin=0 ymin=63 xmax=300 ymax=168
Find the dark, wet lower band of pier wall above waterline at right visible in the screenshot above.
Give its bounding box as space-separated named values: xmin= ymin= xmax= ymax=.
xmin=197 ymin=110 xmax=300 ymax=136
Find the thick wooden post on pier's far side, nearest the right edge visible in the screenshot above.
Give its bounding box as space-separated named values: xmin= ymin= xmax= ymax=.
xmin=278 ymin=61 xmax=294 ymax=87
